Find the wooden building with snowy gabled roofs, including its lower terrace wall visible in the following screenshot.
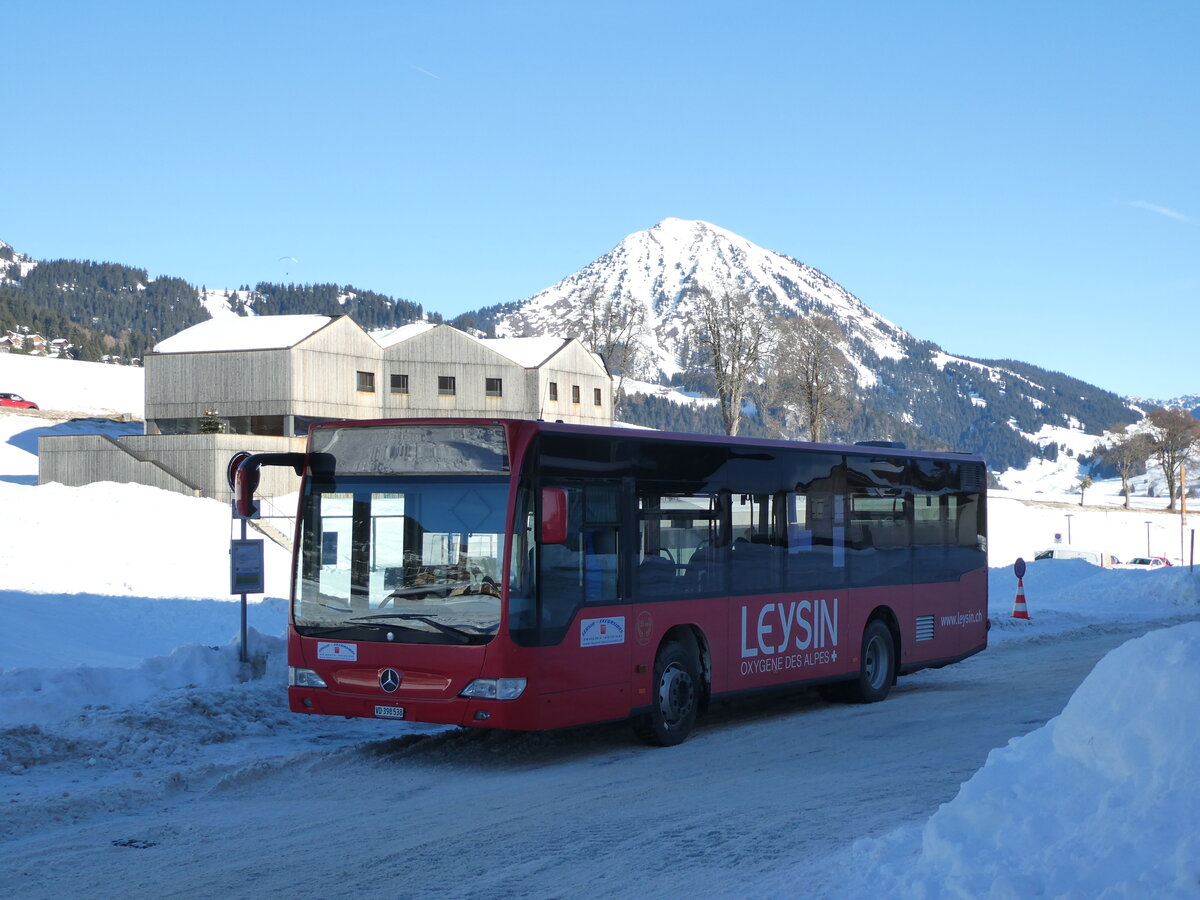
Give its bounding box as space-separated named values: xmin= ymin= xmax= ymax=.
xmin=38 ymin=316 xmax=612 ymax=500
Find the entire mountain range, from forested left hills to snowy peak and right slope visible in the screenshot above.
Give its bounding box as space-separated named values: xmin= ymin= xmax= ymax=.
xmin=0 ymin=225 xmax=1180 ymax=469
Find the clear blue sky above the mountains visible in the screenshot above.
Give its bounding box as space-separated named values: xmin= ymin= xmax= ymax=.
xmin=0 ymin=0 xmax=1200 ymax=398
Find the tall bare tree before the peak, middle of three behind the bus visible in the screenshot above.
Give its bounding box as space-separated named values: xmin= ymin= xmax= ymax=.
xmin=696 ymin=288 xmax=770 ymax=436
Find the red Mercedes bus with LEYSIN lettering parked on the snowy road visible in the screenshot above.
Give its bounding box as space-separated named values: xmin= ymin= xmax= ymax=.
xmin=238 ymin=419 xmax=988 ymax=745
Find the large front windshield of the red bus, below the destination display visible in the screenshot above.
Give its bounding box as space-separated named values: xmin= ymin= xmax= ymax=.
xmin=294 ymin=476 xmax=509 ymax=643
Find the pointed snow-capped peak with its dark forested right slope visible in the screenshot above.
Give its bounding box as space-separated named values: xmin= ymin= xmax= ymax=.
xmin=472 ymin=218 xmax=1138 ymax=468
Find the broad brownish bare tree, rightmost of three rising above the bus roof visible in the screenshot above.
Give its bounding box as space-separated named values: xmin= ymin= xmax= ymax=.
xmin=763 ymin=314 xmax=854 ymax=440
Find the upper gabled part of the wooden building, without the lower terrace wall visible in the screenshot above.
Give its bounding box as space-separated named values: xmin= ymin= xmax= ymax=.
xmin=143 ymin=316 xmax=612 ymax=437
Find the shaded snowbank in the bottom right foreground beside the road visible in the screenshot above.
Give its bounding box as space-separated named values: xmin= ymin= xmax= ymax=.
xmin=773 ymin=623 xmax=1200 ymax=898
